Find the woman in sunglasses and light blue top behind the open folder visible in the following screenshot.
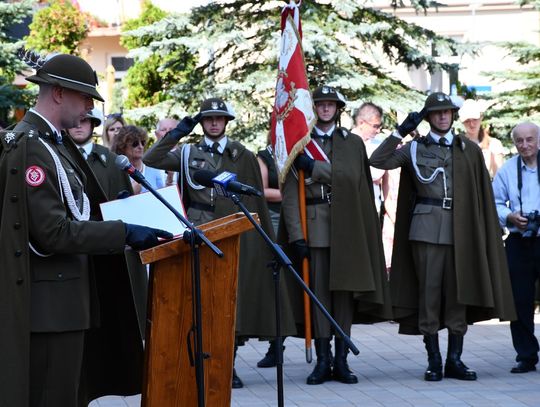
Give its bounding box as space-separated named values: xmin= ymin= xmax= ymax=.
xmin=111 ymin=125 xmax=165 ymax=194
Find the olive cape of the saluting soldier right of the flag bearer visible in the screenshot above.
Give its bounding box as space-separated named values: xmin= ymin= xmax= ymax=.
xmin=371 ymin=135 xmax=516 ymax=334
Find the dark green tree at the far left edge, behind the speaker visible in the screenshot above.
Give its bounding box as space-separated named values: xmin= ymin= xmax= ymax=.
xmin=0 ymin=0 xmax=33 ymax=120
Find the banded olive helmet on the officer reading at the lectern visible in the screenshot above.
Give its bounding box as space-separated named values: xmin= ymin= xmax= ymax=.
xmin=26 ymin=54 xmax=104 ymax=102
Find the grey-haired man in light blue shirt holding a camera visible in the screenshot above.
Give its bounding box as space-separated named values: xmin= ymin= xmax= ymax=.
xmin=493 ymin=122 xmax=540 ymax=373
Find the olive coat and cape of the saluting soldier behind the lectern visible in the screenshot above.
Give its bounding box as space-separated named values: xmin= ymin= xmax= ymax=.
xmin=143 ymin=135 xmax=296 ymax=338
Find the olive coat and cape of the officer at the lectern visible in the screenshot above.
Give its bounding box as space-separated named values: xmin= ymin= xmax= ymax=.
xmin=0 ymin=112 xmax=142 ymax=407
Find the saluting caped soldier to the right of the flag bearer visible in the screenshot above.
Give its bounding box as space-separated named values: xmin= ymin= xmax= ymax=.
xmin=370 ymin=92 xmax=515 ymax=381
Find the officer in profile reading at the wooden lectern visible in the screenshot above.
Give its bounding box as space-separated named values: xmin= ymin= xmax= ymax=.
xmin=0 ymin=52 xmax=172 ymax=407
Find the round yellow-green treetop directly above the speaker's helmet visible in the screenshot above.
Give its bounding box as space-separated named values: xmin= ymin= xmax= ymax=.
xmin=26 ymin=0 xmax=89 ymax=55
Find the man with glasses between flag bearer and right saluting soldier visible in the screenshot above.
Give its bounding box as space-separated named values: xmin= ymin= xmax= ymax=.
xmin=351 ymin=102 xmax=388 ymax=222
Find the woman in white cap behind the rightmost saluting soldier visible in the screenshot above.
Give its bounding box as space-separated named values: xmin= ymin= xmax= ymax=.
xmin=459 ymin=99 xmax=504 ymax=178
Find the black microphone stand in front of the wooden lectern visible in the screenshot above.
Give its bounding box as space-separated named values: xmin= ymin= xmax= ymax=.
xmin=133 ymin=175 xmax=223 ymax=407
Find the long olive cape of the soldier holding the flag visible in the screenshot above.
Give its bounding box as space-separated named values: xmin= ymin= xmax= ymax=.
xmin=279 ymin=128 xmax=392 ymax=323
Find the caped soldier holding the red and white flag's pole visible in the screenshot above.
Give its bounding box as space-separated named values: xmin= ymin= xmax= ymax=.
xmin=281 ymin=86 xmax=391 ymax=385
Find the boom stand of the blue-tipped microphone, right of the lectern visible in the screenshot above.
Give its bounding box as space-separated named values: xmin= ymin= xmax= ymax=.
xmin=229 ymin=192 xmax=360 ymax=407
